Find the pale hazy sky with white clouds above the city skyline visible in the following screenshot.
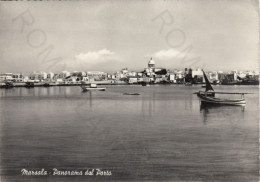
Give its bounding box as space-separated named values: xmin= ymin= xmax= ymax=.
xmin=0 ymin=0 xmax=259 ymax=73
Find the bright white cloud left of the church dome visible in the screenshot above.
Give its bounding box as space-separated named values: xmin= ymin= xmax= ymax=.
xmin=75 ymin=49 xmax=115 ymax=62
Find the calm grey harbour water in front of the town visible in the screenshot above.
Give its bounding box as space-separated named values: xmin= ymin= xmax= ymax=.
xmin=0 ymin=85 xmax=259 ymax=182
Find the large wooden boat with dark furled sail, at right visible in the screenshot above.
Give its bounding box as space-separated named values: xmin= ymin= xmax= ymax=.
xmin=197 ymin=70 xmax=249 ymax=105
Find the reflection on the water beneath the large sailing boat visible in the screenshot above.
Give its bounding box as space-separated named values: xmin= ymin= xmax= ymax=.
xmin=200 ymin=103 xmax=245 ymax=125
